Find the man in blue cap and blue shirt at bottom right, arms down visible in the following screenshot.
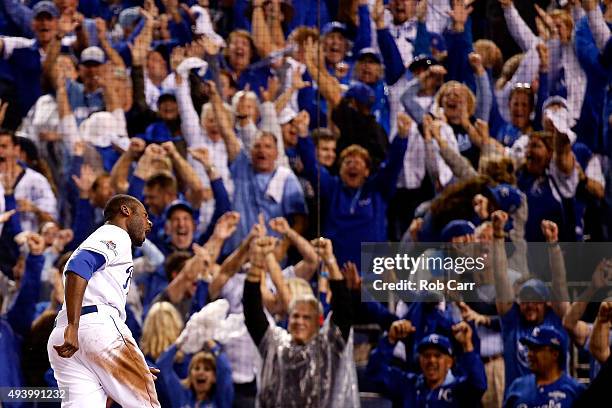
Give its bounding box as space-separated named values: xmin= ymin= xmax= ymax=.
xmin=504 ymin=325 xmax=585 ymax=408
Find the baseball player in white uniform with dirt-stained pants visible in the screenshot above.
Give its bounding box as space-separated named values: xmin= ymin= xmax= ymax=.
xmin=47 ymin=194 xmax=160 ymax=408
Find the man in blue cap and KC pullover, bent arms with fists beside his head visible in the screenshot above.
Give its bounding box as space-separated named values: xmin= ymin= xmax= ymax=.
xmin=367 ymin=320 xmax=487 ymax=408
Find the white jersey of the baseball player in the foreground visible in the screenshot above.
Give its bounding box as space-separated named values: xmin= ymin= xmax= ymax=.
xmin=62 ymin=224 xmax=134 ymax=321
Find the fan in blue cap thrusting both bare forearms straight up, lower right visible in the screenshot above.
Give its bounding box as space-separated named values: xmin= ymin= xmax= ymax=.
xmin=491 ymin=210 xmax=569 ymax=392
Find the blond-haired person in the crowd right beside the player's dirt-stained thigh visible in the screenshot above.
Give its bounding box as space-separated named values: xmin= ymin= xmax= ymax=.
xmin=140 ymin=302 xmax=189 ymax=407
